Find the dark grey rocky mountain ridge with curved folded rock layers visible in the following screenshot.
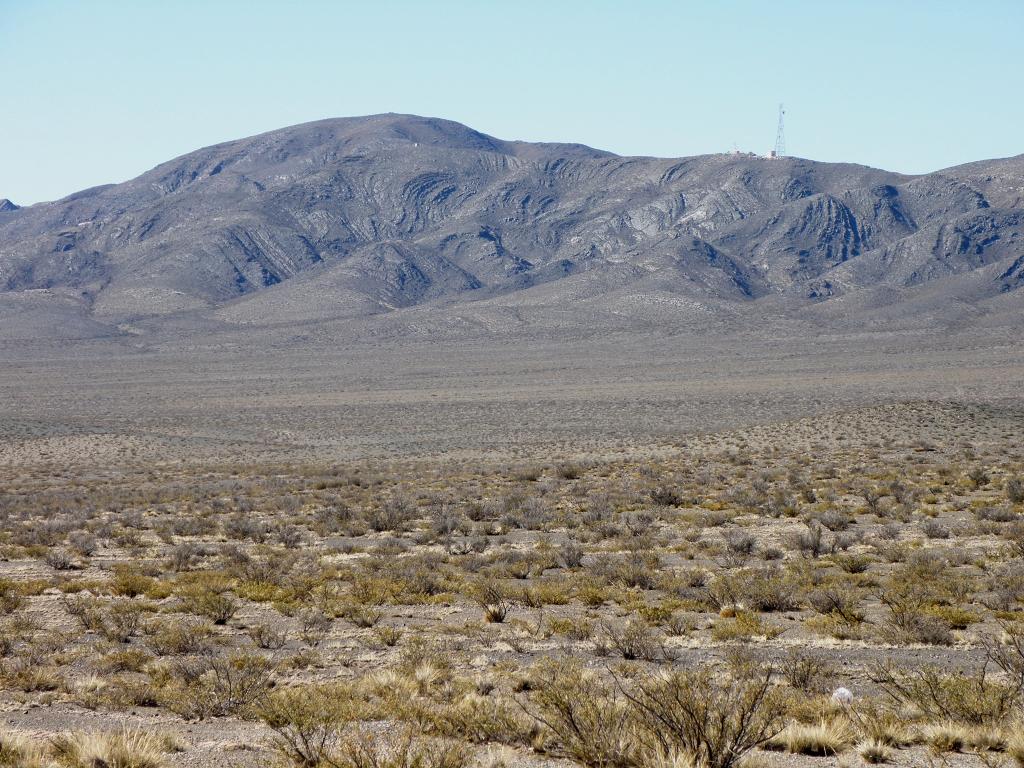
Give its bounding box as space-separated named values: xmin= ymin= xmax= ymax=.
xmin=0 ymin=115 xmax=1024 ymax=335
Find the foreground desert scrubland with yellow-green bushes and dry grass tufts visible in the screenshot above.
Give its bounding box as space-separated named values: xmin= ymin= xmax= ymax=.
xmin=0 ymin=393 xmax=1024 ymax=768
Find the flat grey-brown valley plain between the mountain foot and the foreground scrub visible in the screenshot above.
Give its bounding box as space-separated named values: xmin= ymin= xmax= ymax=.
xmin=0 ymin=327 xmax=1024 ymax=466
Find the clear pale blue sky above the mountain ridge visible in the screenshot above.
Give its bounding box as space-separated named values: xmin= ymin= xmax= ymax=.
xmin=0 ymin=0 xmax=1024 ymax=205
